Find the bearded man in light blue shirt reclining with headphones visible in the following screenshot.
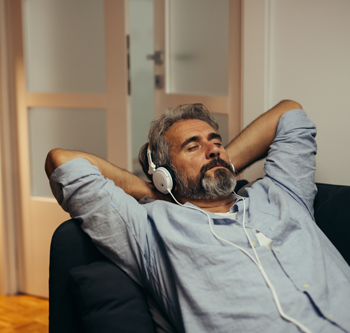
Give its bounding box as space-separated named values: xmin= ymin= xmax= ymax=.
xmin=46 ymin=100 xmax=350 ymax=333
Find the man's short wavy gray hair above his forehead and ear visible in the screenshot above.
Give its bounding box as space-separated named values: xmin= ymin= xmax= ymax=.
xmin=139 ymin=103 xmax=219 ymax=181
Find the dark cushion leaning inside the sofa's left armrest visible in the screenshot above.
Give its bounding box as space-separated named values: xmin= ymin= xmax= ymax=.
xmin=69 ymin=259 xmax=155 ymax=333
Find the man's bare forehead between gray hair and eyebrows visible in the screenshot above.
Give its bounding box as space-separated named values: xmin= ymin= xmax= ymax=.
xmin=164 ymin=119 xmax=216 ymax=145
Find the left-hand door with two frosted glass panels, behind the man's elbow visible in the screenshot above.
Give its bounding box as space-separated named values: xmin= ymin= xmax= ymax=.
xmin=7 ymin=0 xmax=131 ymax=297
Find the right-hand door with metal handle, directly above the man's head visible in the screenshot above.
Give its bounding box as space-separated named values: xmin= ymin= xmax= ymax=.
xmin=154 ymin=0 xmax=241 ymax=143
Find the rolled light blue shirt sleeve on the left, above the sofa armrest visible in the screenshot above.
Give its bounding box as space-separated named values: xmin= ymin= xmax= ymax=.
xmin=50 ymin=159 xmax=153 ymax=284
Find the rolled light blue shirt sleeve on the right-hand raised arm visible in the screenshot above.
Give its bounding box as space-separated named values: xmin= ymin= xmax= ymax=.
xmin=264 ymin=109 xmax=317 ymax=216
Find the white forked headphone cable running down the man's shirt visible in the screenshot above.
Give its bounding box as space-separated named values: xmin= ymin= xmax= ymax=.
xmin=169 ymin=191 xmax=312 ymax=333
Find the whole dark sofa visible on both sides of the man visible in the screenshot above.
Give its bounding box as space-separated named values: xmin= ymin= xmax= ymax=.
xmin=49 ymin=180 xmax=350 ymax=333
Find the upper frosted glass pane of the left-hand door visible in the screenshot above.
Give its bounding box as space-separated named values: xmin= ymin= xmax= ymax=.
xmin=22 ymin=0 xmax=106 ymax=93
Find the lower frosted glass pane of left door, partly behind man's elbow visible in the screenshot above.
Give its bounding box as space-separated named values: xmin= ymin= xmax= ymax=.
xmin=28 ymin=108 xmax=107 ymax=197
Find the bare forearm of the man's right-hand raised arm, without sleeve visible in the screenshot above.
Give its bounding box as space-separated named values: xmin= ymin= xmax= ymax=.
xmin=226 ymin=100 xmax=302 ymax=173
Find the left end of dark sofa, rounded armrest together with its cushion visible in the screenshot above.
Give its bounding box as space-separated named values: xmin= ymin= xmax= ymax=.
xmin=49 ymin=220 xmax=155 ymax=333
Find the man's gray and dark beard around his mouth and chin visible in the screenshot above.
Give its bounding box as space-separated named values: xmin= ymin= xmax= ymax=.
xmin=173 ymin=161 xmax=237 ymax=200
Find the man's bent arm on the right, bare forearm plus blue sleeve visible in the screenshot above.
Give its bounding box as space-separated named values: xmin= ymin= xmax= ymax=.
xmin=229 ymin=101 xmax=317 ymax=215
